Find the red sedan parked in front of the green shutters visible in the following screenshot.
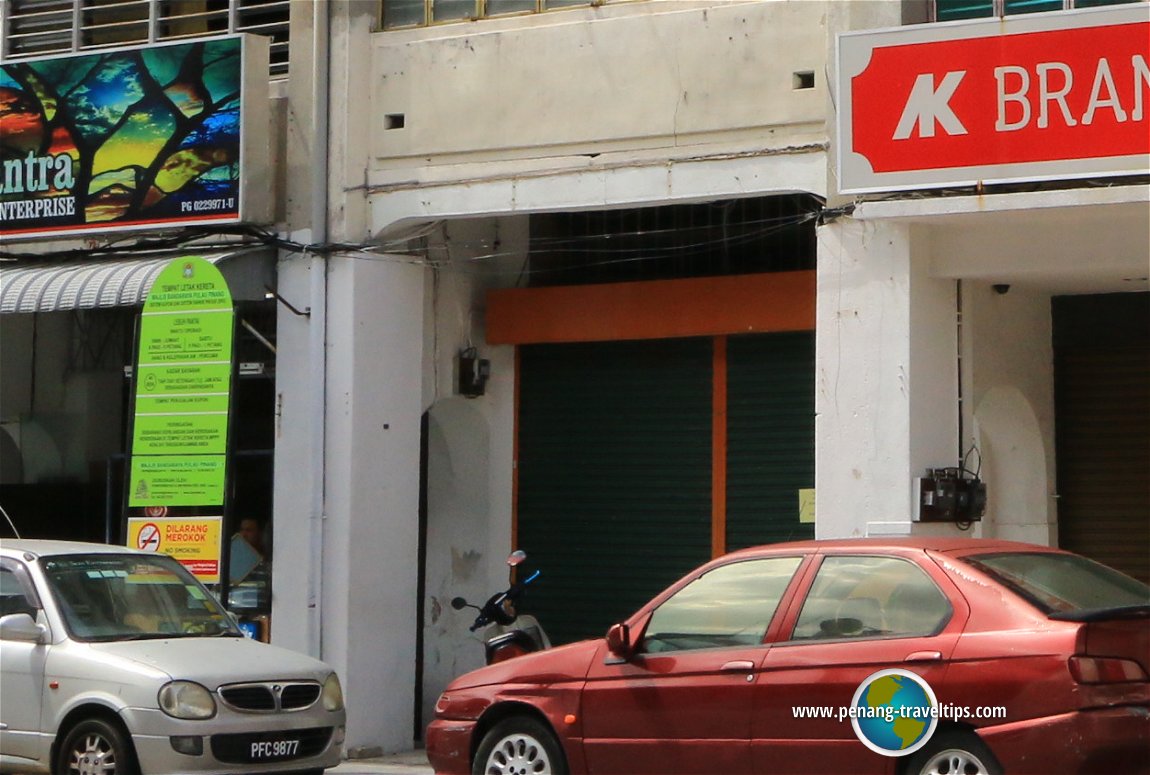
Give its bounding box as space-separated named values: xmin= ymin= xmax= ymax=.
xmin=426 ymin=538 xmax=1150 ymax=775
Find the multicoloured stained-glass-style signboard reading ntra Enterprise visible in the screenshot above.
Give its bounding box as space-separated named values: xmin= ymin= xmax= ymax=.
xmin=0 ymin=36 xmax=270 ymax=239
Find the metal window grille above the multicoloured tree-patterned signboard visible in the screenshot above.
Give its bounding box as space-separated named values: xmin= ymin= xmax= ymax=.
xmin=0 ymin=0 xmax=291 ymax=78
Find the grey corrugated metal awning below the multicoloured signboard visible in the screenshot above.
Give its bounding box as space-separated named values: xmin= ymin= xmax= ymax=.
xmin=0 ymin=246 xmax=268 ymax=314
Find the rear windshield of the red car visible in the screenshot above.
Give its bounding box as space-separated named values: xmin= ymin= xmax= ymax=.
xmin=964 ymin=552 xmax=1150 ymax=619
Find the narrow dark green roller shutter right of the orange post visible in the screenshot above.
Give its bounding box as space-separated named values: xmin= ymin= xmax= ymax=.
xmin=727 ymin=331 xmax=814 ymax=551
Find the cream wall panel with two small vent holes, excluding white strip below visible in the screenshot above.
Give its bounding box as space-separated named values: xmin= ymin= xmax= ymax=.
xmin=371 ymin=0 xmax=827 ymax=168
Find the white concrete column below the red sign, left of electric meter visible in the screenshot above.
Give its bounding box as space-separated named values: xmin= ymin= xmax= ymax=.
xmin=815 ymin=213 xmax=959 ymax=538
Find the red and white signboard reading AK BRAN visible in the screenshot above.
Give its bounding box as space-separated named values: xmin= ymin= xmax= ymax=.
xmin=837 ymin=2 xmax=1150 ymax=193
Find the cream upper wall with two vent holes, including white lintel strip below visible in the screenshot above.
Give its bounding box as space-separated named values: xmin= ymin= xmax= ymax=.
xmin=368 ymin=0 xmax=827 ymax=238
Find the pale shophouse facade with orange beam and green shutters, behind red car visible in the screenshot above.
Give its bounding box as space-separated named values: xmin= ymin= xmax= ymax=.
xmin=6 ymin=0 xmax=1150 ymax=753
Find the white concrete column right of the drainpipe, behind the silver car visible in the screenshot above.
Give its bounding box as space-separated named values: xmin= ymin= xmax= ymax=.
xmin=322 ymin=251 xmax=424 ymax=751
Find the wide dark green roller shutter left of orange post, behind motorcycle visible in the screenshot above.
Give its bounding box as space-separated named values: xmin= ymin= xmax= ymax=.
xmin=518 ymin=339 xmax=712 ymax=643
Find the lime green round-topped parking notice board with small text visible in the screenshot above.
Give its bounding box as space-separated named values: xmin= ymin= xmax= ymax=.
xmin=128 ymin=256 xmax=235 ymax=507
